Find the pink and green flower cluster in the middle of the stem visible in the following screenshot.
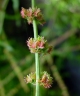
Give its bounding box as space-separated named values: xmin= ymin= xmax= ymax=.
xmin=27 ymin=36 xmax=47 ymax=53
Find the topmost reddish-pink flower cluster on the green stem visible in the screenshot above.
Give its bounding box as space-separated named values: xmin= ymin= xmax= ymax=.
xmin=21 ymin=7 xmax=45 ymax=25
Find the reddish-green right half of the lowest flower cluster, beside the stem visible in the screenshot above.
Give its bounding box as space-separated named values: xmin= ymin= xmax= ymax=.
xmin=40 ymin=71 xmax=52 ymax=88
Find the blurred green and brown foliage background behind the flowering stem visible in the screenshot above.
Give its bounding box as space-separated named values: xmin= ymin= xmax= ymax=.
xmin=0 ymin=0 xmax=80 ymax=96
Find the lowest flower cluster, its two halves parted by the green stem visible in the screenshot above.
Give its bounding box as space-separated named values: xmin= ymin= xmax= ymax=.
xmin=24 ymin=71 xmax=52 ymax=88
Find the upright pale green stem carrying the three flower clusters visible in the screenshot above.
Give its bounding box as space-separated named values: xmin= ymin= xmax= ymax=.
xmin=32 ymin=0 xmax=40 ymax=96
